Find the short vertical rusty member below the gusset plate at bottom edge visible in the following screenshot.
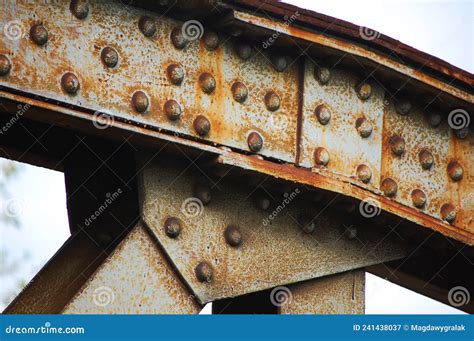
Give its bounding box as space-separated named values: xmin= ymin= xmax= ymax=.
xmin=280 ymin=270 xmax=365 ymax=314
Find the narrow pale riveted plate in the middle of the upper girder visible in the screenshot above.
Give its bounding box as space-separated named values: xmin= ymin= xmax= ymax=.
xmin=300 ymin=60 xmax=384 ymax=187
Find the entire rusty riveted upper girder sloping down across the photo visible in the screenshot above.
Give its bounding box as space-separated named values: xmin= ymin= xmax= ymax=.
xmin=0 ymin=0 xmax=474 ymax=245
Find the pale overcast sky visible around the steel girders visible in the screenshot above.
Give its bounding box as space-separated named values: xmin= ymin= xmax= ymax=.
xmin=0 ymin=0 xmax=474 ymax=314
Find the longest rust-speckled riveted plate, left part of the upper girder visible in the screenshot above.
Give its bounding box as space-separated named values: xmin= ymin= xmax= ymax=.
xmin=0 ymin=1 xmax=298 ymax=161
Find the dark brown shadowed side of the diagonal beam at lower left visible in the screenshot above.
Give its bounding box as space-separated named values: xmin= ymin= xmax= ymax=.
xmin=3 ymin=233 xmax=107 ymax=314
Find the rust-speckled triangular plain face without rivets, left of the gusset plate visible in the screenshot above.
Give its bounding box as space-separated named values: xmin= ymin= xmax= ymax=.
xmin=62 ymin=224 xmax=201 ymax=314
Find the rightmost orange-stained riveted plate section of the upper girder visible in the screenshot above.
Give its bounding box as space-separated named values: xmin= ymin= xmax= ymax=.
xmin=381 ymin=102 xmax=474 ymax=232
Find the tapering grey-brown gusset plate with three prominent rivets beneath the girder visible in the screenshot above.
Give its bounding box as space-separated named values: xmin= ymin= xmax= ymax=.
xmin=141 ymin=160 xmax=407 ymax=303
